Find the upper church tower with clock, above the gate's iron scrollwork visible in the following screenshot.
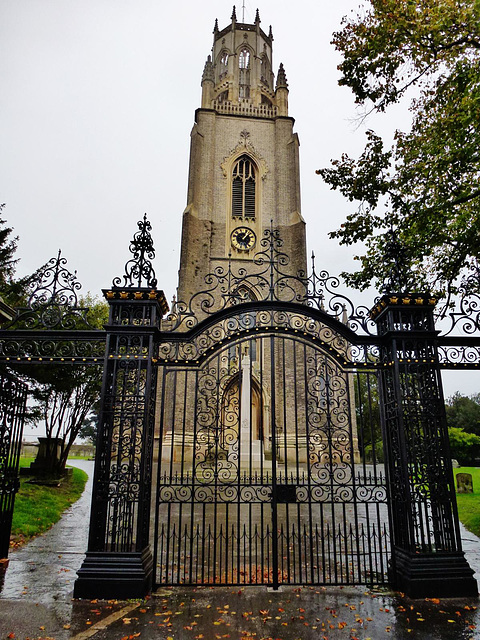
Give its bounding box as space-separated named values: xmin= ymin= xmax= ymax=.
xmin=178 ymin=7 xmax=306 ymax=301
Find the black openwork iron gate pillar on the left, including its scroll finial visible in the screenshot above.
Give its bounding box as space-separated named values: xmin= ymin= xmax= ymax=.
xmin=74 ymin=218 xmax=168 ymax=598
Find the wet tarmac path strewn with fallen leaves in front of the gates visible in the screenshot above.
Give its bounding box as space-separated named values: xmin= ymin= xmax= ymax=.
xmin=0 ymin=461 xmax=480 ymax=640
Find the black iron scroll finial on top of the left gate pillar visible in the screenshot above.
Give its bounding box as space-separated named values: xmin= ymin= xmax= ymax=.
xmin=112 ymin=213 xmax=157 ymax=289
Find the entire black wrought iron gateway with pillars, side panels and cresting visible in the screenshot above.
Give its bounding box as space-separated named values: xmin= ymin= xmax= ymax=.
xmin=0 ymin=217 xmax=474 ymax=598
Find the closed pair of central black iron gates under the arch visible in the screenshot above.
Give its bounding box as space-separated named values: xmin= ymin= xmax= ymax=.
xmin=154 ymin=322 xmax=390 ymax=587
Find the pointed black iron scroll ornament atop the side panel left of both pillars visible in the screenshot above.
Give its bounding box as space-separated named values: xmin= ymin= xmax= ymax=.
xmin=7 ymin=250 xmax=93 ymax=330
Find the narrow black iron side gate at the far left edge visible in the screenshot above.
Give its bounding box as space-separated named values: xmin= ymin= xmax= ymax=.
xmin=0 ymin=374 xmax=27 ymax=558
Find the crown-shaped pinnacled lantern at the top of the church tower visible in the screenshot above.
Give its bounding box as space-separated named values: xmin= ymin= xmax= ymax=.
xmin=202 ymin=6 xmax=288 ymax=118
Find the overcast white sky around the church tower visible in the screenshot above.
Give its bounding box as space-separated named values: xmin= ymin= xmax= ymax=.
xmin=0 ymin=0 xmax=472 ymax=395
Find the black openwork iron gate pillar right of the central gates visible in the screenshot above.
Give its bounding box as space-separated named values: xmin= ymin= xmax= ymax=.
xmin=372 ymin=294 xmax=477 ymax=598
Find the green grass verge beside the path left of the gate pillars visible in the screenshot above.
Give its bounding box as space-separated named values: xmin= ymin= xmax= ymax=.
xmin=10 ymin=458 xmax=88 ymax=548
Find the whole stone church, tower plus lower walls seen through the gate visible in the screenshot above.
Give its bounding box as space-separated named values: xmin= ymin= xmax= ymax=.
xmin=157 ymin=8 xmax=358 ymax=477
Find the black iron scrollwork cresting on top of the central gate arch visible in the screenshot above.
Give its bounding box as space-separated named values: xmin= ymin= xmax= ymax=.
xmin=164 ymin=227 xmax=376 ymax=336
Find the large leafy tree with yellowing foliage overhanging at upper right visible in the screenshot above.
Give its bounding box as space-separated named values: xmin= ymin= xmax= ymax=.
xmin=317 ymin=0 xmax=480 ymax=296
